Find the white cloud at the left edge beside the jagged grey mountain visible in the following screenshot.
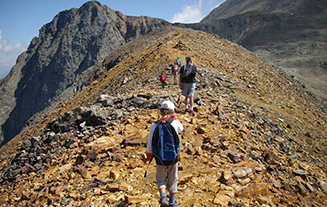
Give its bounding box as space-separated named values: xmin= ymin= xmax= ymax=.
xmin=0 ymin=30 xmax=26 ymax=78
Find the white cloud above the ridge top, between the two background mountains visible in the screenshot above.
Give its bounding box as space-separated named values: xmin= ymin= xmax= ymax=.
xmin=171 ymin=0 xmax=205 ymax=23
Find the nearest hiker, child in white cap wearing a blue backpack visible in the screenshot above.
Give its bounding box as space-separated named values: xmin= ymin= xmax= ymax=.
xmin=144 ymin=101 xmax=183 ymax=207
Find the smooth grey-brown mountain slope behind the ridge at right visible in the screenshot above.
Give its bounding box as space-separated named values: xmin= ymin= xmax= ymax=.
xmin=189 ymin=0 xmax=327 ymax=111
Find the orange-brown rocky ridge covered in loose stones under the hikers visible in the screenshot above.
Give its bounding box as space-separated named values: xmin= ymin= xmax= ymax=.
xmin=0 ymin=27 xmax=327 ymax=207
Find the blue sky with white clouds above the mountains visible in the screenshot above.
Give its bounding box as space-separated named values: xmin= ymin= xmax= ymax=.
xmin=0 ymin=0 xmax=225 ymax=78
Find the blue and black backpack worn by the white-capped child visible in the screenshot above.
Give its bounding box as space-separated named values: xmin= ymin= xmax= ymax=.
xmin=152 ymin=118 xmax=180 ymax=166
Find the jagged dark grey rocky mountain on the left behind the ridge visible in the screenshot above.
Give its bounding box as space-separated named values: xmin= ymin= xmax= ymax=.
xmin=0 ymin=1 xmax=169 ymax=144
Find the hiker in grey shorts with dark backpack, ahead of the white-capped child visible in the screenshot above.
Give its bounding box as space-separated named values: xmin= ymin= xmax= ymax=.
xmin=179 ymin=57 xmax=197 ymax=115
